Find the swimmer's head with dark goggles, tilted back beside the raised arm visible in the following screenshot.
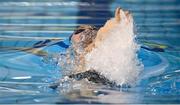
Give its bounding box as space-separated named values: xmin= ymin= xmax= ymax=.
xmin=70 ymin=25 xmax=98 ymax=48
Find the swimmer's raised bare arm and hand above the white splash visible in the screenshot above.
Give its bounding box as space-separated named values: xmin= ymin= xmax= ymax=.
xmin=93 ymin=8 xmax=133 ymax=47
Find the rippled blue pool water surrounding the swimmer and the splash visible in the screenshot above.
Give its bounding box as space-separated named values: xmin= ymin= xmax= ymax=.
xmin=0 ymin=0 xmax=180 ymax=104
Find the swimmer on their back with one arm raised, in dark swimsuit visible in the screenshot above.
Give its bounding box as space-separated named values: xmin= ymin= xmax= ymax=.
xmin=69 ymin=8 xmax=133 ymax=86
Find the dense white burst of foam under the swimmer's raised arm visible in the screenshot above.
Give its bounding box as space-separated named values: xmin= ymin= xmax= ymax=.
xmin=86 ymin=18 xmax=143 ymax=86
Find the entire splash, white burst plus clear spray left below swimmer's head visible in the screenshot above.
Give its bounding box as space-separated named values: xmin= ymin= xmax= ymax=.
xmin=59 ymin=8 xmax=143 ymax=86
